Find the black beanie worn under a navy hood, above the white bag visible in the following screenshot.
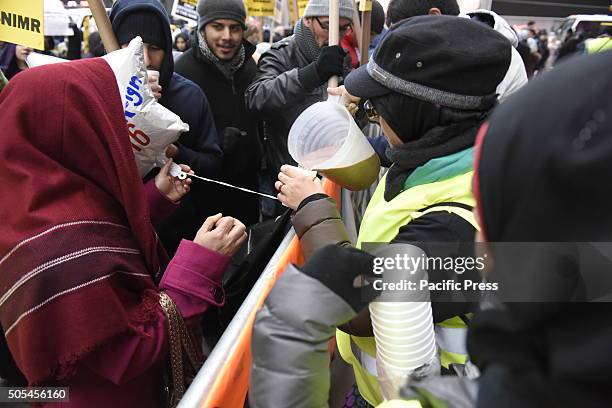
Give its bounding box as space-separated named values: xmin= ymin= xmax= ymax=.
xmin=115 ymin=10 xmax=166 ymax=50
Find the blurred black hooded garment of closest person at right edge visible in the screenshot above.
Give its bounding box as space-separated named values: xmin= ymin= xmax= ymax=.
xmin=468 ymin=49 xmax=612 ymax=407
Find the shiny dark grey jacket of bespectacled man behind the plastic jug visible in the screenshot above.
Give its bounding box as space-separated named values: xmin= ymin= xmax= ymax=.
xmin=245 ymin=36 xmax=350 ymax=176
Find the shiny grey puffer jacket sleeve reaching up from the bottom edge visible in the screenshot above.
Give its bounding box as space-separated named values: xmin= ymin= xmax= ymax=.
xmin=249 ymin=265 xmax=355 ymax=408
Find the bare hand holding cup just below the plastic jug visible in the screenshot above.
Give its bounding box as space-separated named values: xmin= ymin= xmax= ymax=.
xmin=274 ymin=164 xmax=324 ymax=211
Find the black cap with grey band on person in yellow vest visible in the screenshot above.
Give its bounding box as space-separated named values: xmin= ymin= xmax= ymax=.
xmin=344 ymin=15 xmax=512 ymax=110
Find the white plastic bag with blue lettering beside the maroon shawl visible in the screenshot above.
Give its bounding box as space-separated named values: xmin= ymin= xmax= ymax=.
xmin=102 ymin=37 xmax=189 ymax=177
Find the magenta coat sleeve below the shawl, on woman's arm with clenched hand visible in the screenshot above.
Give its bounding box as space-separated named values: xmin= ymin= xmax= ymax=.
xmin=77 ymin=240 xmax=229 ymax=384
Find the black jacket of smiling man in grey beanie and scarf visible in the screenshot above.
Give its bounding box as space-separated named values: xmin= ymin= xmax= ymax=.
xmin=176 ymin=33 xmax=261 ymax=225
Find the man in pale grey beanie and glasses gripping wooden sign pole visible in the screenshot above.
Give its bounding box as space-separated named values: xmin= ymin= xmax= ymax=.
xmin=246 ymin=0 xmax=353 ymax=217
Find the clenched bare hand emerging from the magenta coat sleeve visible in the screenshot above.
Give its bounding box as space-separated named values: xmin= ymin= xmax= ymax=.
xmin=193 ymin=214 xmax=247 ymax=257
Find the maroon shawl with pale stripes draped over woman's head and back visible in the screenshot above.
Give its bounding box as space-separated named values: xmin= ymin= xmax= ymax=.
xmin=0 ymin=58 xmax=166 ymax=384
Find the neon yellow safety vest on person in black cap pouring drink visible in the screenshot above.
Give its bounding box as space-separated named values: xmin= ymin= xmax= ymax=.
xmin=336 ymin=171 xmax=479 ymax=406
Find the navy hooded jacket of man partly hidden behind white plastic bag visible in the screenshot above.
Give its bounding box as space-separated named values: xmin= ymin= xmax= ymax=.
xmin=110 ymin=0 xmax=223 ymax=252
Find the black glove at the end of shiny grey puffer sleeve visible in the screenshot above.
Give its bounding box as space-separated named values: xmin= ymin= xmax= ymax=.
xmin=300 ymin=245 xmax=380 ymax=313
